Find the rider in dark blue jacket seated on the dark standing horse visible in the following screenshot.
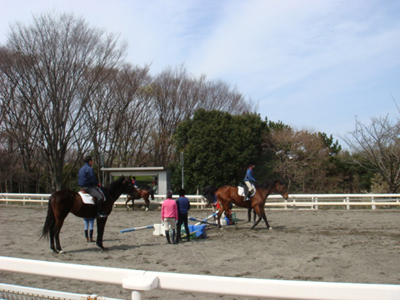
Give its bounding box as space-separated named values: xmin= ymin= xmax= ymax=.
xmin=78 ymin=156 xmax=107 ymax=218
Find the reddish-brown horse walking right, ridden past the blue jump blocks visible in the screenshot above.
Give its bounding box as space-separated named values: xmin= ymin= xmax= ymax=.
xmin=206 ymin=180 xmax=289 ymax=229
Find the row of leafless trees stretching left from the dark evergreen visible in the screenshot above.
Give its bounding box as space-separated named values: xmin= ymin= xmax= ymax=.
xmin=0 ymin=14 xmax=256 ymax=192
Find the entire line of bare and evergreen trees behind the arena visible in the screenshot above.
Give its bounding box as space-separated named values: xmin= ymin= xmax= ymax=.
xmin=0 ymin=14 xmax=400 ymax=194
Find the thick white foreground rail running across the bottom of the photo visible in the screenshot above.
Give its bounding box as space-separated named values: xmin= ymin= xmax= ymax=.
xmin=0 ymin=256 xmax=400 ymax=300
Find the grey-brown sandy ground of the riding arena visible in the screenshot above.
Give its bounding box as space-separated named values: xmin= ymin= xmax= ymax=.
xmin=0 ymin=205 xmax=400 ymax=300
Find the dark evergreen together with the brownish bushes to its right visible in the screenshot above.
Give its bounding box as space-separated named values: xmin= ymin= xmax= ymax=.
xmin=173 ymin=109 xmax=371 ymax=193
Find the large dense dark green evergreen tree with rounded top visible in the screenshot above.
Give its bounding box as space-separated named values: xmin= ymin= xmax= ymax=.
xmin=173 ymin=109 xmax=268 ymax=193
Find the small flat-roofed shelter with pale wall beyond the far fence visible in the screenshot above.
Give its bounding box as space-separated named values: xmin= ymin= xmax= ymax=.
xmin=101 ymin=167 xmax=171 ymax=195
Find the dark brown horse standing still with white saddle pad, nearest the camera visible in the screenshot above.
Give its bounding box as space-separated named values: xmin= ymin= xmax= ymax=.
xmin=42 ymin=177 xmax=134 ymax=253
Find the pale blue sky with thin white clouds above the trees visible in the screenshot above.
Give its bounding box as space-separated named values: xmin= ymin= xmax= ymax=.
xmin=0 ymin=0 xmax=400 ymax=146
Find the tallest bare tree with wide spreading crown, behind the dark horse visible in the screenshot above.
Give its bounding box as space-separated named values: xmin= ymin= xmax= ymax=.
xmin=0 ymin=14 xmax=125 ymax=189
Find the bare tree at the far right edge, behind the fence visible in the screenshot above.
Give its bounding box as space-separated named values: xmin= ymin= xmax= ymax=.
xmin=342 ymin=116 xmax=400 ymax=193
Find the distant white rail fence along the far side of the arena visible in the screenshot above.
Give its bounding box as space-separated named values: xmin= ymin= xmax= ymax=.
xmin=0 ymin=193 xmax=400 ymax=209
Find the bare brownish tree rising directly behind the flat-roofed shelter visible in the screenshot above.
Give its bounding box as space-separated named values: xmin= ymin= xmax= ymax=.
xmin=88 ymin=64 xmax=152 ymax=171
